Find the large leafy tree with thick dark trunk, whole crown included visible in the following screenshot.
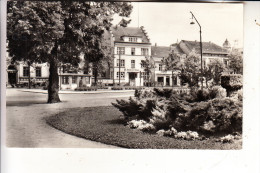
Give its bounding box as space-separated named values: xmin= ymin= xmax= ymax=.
xmin=7 ymin=1 xmax=132 ymax=103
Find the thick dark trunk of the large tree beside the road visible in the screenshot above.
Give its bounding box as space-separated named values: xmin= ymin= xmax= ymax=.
xmin=48 ymin=59 xmax=60 ymax=103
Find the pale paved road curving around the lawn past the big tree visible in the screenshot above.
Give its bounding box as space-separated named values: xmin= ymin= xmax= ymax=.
xmin=6 ymin=89 xmax=134 ymax=148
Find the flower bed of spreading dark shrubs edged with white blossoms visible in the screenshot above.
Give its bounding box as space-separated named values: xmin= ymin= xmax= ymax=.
xmin=112 ymin=86 xmax=242 ymax=140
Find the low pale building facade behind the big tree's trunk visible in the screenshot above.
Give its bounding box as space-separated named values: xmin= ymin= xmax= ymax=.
xmin=6 ymin=61 xmax=92 ymax=90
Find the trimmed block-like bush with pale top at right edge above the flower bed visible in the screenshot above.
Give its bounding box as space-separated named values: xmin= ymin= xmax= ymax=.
xmin=221 ymin=74 xmax=243 ymax=96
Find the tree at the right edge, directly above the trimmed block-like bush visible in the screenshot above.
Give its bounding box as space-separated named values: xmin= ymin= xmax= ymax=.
xmin=228 ymin=51 xmax=243 ymax=74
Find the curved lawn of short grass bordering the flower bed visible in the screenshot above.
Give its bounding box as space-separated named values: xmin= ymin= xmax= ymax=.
xmin=46 ymin=106 xmax=242 ymax=150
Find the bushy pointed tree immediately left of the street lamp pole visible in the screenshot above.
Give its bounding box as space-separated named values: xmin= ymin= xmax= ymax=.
xmin=180 ymin=51 xmax=201 ymax=87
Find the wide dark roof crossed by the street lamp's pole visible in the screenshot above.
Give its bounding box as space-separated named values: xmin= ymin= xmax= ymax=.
xmin=181 ymin=40 xmax=228 ymax=54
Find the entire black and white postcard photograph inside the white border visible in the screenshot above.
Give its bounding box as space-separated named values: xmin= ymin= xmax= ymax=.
xmin=6 ymin=1 xmax=243 ymax=150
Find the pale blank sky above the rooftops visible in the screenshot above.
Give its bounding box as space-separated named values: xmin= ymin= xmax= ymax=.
xmin=113 ymin=2 xmax=243 ymax=48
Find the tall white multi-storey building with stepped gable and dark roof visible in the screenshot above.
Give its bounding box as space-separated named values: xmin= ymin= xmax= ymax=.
xmin=110 ymin=26 xmax=151 ymax=86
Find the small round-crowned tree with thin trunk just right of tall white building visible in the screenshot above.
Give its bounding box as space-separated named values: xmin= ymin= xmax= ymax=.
xmin=162 ymin=52 xmax=183 ymax=87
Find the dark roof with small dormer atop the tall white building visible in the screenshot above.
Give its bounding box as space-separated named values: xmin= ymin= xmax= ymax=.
xmin=111 ymin=26 xmax=150 ymax=43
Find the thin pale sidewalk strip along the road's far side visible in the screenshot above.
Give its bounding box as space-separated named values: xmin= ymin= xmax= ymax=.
xmin=19 ymin=89 xmax=134 ymax=94
